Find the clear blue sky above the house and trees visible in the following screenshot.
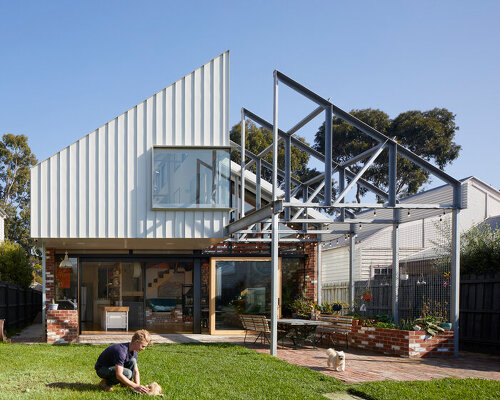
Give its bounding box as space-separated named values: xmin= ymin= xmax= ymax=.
xmin=0 ymin=0 xmax=500 ymax=189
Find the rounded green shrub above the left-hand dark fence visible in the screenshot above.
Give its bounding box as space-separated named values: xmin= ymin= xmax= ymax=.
xmin=0 ymin=240 xmax=33 ymax=288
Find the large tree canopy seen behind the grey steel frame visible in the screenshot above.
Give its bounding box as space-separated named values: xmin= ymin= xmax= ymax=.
xmin=313 ymin=108 xmax=461 ymax=201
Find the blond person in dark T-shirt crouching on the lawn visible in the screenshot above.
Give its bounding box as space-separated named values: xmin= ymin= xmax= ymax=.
xmin=94 ymin=329 xmax=151 ymax=393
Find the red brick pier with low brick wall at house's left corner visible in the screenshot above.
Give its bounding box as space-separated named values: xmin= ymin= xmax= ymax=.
xmin=45 ymin=249 xmax=78 ymax=343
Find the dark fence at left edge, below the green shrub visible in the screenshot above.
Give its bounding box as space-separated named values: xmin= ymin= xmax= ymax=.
xmin=0 ymin=281 xmax=42 ymax=329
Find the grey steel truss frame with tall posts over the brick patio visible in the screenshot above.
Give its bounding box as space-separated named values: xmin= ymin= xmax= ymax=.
xmin=225 ymin=71 xmax=462 ymax=356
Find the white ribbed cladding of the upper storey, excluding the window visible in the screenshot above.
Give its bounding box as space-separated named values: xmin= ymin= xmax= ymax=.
xmin=31 ymin=51 xmax=229 ymax=238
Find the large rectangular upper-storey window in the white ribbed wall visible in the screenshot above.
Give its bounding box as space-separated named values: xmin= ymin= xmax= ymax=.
xmin=152 ymin=147 xmax=231 ymax=209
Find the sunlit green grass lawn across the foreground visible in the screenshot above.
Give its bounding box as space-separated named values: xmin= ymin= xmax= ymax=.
xmin=0 ymin=343 xmax=500 ymax=400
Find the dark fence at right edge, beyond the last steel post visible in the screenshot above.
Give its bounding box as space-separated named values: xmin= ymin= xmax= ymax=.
xmin=460 ymin=273 xmax=500 ymax=354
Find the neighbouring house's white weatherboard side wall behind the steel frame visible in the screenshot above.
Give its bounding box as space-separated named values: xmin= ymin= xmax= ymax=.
xmin=322 ymin=177 xmax=500 ymax=285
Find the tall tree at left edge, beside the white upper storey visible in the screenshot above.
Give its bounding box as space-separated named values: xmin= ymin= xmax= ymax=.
xmin=0 ymin=134 xmax=37 ymax=255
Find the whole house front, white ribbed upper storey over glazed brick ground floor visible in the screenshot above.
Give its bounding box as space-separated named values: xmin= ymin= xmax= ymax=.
xmin=31 ymin=52 xmax=317 ymax=343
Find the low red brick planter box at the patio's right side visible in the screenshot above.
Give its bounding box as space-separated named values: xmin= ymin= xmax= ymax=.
xmin=349 ymin=326 xmax=454 ymax=358
